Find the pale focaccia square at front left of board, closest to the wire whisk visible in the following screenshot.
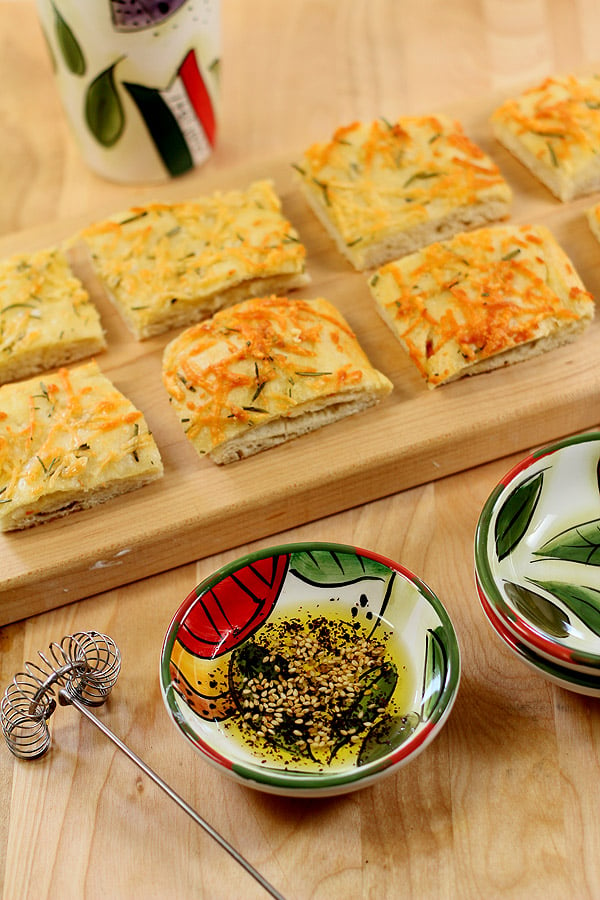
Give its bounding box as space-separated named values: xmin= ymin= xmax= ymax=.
xmin=0 ymin=361 xmax=163 ymax=531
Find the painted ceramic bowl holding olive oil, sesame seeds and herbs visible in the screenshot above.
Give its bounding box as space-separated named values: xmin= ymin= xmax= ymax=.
xmin=160 ymin=543 xmax=460 ymax=797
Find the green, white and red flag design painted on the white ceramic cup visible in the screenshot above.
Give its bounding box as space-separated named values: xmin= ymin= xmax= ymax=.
xmin=124 ymin=50 xmax=216 ymax=175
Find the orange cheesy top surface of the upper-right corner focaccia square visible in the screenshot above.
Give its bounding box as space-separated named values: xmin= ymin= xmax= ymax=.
xmin=491 ymin=75 xmax=600 ymax=176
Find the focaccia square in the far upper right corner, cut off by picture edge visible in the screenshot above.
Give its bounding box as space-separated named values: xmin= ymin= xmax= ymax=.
xmin=490 ymin=75 xmax=600 ymax=201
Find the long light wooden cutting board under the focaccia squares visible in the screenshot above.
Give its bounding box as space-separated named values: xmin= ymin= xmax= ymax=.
xmin=0 ymin=101 xmax=600 ymax=624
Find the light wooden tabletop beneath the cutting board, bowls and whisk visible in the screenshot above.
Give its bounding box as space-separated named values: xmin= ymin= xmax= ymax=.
xmin=0 ymin=0 xmax=600 ymax=900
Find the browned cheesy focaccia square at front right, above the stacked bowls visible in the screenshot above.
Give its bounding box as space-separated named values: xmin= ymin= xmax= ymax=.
xmin=369 ymin=225 xmax=594 ymax=388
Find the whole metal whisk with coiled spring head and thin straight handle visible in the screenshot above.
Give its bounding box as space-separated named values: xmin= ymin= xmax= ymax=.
xmin=0 ymin=631 xmax=284 ymax=900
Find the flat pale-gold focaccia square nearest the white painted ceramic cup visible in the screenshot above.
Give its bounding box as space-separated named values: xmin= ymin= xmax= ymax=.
xmin=77 ymin=180 xmax=310 ymax=340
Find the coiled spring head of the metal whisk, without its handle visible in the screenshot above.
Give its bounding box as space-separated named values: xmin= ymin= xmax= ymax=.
xmin=0 ymin=631 xmax=121 ymax=759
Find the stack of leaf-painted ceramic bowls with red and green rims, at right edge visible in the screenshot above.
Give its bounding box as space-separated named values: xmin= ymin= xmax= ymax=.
xmin=475 ymin=433 xmax=600 ymax=697
